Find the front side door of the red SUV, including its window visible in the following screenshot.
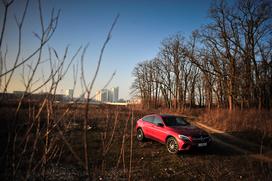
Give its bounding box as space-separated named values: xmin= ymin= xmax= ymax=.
xmin=150 ymin=116 xmax=167 ymax=143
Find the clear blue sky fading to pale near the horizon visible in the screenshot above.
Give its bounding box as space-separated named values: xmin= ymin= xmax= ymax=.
xmin=0 ymin=0 xmax=211 ymax=99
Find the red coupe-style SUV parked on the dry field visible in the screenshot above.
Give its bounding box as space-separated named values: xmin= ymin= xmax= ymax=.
xmin=136 ymin=114 xmax=212 ymax=153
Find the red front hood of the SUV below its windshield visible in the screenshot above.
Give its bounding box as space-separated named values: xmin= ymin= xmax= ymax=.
xmin=169 ymin=125 xmax=207 ymax=136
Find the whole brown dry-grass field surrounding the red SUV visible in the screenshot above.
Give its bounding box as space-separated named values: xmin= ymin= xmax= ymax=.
xmin=0 ymin=104 xmax=272 ymax=180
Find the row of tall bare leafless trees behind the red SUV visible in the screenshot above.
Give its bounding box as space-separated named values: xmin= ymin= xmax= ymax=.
xmin=132 ymin=0 xmax=272 ymax=110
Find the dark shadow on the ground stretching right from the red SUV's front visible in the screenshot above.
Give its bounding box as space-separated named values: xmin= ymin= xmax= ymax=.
xmin=179 ymin=130 xmax=272 ymax=156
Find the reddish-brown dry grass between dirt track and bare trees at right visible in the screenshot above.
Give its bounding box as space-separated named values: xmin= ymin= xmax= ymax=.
xmin=197 ymin=109 xmax=272 ymax=147
